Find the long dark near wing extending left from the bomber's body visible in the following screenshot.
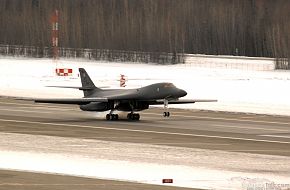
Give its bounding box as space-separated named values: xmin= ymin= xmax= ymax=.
xmin=34 ymin=98 xmax=108 ymax=105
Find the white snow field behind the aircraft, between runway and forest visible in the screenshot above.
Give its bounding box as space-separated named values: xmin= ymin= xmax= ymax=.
xmin=0 ymin=57 xmax=290 ymax=115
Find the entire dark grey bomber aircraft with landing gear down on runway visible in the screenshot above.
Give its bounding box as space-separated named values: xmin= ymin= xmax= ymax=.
xmin=34 ymin=68 xmax=216 ymax=120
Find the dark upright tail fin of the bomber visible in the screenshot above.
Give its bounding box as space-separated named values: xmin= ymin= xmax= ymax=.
xmin=79 ymin=68 xmax=101 ymax=97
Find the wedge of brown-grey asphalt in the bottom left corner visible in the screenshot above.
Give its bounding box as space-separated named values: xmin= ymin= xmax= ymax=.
xmin=0 ymin=170 xmax=196 ymax=190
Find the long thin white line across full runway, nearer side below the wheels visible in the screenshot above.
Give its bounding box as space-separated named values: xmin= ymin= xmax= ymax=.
xmin=0 ymin=119 xmax=290 ymax=144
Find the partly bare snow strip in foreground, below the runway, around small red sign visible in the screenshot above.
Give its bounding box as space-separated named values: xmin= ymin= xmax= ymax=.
xmin=0 ymin=133 xmax=290 ymax=190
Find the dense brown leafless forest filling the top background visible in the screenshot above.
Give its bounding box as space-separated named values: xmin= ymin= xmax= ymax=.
xmin=0 ymin=0 xmax=290 ymax=59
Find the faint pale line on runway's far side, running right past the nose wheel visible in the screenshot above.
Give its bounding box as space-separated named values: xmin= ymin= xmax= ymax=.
xmin=143 ymin=112 xmax=290 ymax=126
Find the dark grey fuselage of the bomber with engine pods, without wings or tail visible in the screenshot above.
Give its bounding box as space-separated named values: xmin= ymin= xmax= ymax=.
xmin=80 ymin=83 xmax=187 ymax=111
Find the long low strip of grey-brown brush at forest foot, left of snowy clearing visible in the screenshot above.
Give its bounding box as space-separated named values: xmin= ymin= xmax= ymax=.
xmin=0 ymin=45 xmax=184 ymax=64
